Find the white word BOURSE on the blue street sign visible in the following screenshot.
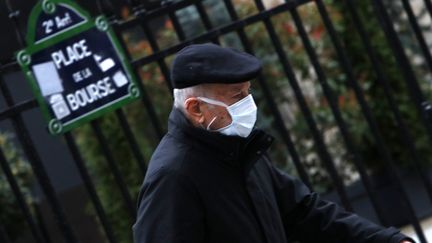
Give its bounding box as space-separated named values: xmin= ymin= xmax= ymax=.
xmin=66 ymin=77 xmax=116 ymax=111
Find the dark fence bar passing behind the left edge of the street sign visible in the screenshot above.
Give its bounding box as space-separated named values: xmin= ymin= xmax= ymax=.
xmin=0 ymin=0 xmax=78 ymax=243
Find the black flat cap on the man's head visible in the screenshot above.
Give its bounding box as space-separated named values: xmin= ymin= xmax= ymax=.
xmin=171 ymin=43 xmax=261 ymax=89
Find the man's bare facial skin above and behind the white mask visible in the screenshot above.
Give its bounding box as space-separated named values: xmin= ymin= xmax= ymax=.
xmin=184 ymin=81 xmax=250 ymax=130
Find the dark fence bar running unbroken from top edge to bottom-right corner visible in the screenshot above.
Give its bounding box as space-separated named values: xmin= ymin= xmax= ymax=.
xmin=315 ymin=0 xmax=426 ymax=243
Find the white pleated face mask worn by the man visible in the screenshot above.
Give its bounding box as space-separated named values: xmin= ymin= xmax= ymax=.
xmin=197 ymin=94 xmax=257 ymax=137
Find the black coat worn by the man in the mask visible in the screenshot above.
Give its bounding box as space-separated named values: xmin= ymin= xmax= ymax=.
xmin=133 ymin=109 xmax=405 ymax=243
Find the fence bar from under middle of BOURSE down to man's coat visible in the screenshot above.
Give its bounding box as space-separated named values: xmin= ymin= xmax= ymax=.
xmin=90 ymin=120 xmax=135 ymax=220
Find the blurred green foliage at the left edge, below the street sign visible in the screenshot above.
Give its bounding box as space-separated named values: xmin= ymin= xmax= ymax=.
xmin=0 ymin=132 xmax=33 ymax=240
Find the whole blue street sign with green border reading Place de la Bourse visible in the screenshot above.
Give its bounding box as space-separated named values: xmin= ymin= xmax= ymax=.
xmin=17 ymin=0 xmax=140 ymax=134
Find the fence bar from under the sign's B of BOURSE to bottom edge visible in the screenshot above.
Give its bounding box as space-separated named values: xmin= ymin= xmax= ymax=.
xmin=64 ymin=132 xmax=117 ymax=243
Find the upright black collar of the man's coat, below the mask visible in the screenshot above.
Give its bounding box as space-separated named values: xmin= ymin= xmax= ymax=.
xmin=168 ymin=108 xmax=274 ymax=165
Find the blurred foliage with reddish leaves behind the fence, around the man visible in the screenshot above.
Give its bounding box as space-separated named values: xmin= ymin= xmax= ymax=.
xmin=74 ymin=0 xmax=430 ymax=243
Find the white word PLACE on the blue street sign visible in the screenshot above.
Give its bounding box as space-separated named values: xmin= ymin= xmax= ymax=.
xmin=51 ymin=40 xmax=92 ymax=69
